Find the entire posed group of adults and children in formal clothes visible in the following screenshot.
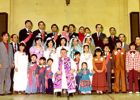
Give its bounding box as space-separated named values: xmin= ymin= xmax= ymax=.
xmin=0 ymin=20 xmax=140 ymax=96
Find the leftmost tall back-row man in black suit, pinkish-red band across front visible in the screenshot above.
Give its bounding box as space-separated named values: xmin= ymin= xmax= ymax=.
xmin=19 ymin=20 xmax=33 ymax=54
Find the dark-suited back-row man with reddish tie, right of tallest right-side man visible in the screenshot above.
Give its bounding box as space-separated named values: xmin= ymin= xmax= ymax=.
xmin=108 ymin=27 xmax=118 ymax=52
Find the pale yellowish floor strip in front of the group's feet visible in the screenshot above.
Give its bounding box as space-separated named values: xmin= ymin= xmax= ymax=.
xmin=0 ymin=94 xmax=140 ymax=100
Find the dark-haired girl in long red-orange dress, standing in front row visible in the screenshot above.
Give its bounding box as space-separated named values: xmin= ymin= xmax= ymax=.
xmin=92 ymin=47 xmax=107 ymax=94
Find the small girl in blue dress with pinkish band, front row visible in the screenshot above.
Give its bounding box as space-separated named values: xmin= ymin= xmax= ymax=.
xmin=79 ymin=62 xmax=93 ymax=94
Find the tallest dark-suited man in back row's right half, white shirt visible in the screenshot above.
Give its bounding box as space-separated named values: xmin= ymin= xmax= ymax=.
xmin=92 ymin=24 xmax=106 ymax=47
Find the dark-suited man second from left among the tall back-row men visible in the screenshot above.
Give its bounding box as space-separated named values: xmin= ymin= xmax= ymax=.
xmin=33 ymin=21 xmax=47 ymax=43
